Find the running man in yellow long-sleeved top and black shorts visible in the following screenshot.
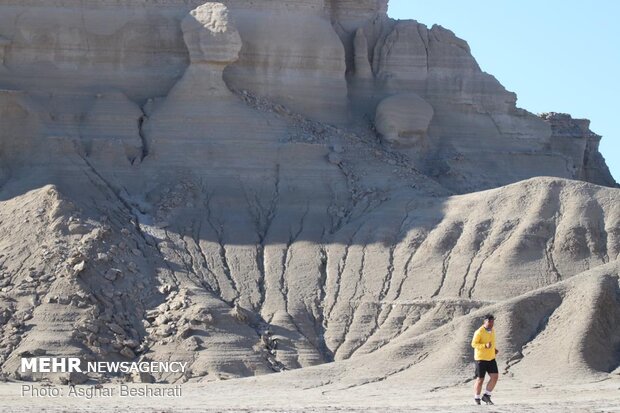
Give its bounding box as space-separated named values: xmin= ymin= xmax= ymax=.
xmin=471 ymin=314 xmax=499 ymax=404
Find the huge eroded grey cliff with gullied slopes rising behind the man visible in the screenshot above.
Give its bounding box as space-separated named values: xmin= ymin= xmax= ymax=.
xmin=0 ymin=0 xmax=620 ymax=381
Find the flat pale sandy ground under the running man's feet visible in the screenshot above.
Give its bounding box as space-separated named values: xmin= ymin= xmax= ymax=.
xmin=0 ymin=377 xmax=620 ymax=413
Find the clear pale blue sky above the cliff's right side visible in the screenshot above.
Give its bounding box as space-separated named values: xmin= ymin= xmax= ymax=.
xmin=389 ymin=0 xmax=620 ymax=181
